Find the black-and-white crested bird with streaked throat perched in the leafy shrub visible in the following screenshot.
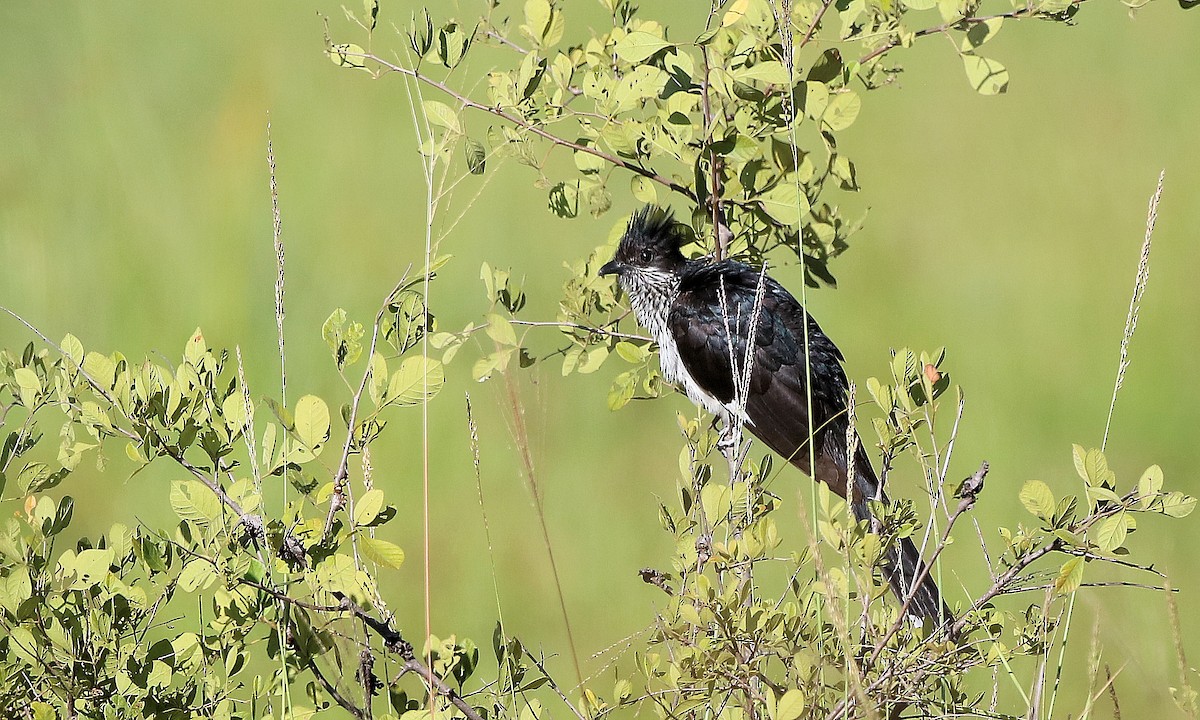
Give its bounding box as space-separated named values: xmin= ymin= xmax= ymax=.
xmin=599 ymin=205 xmax=953 ymax=624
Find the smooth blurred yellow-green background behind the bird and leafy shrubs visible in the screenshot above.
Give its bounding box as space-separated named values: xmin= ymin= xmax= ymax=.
xmin=0 ymin=0 xmax=1200 ymax=716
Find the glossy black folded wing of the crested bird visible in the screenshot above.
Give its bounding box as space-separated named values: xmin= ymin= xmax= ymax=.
xmin=667 ymin=260 xmax=859 ymax=497
